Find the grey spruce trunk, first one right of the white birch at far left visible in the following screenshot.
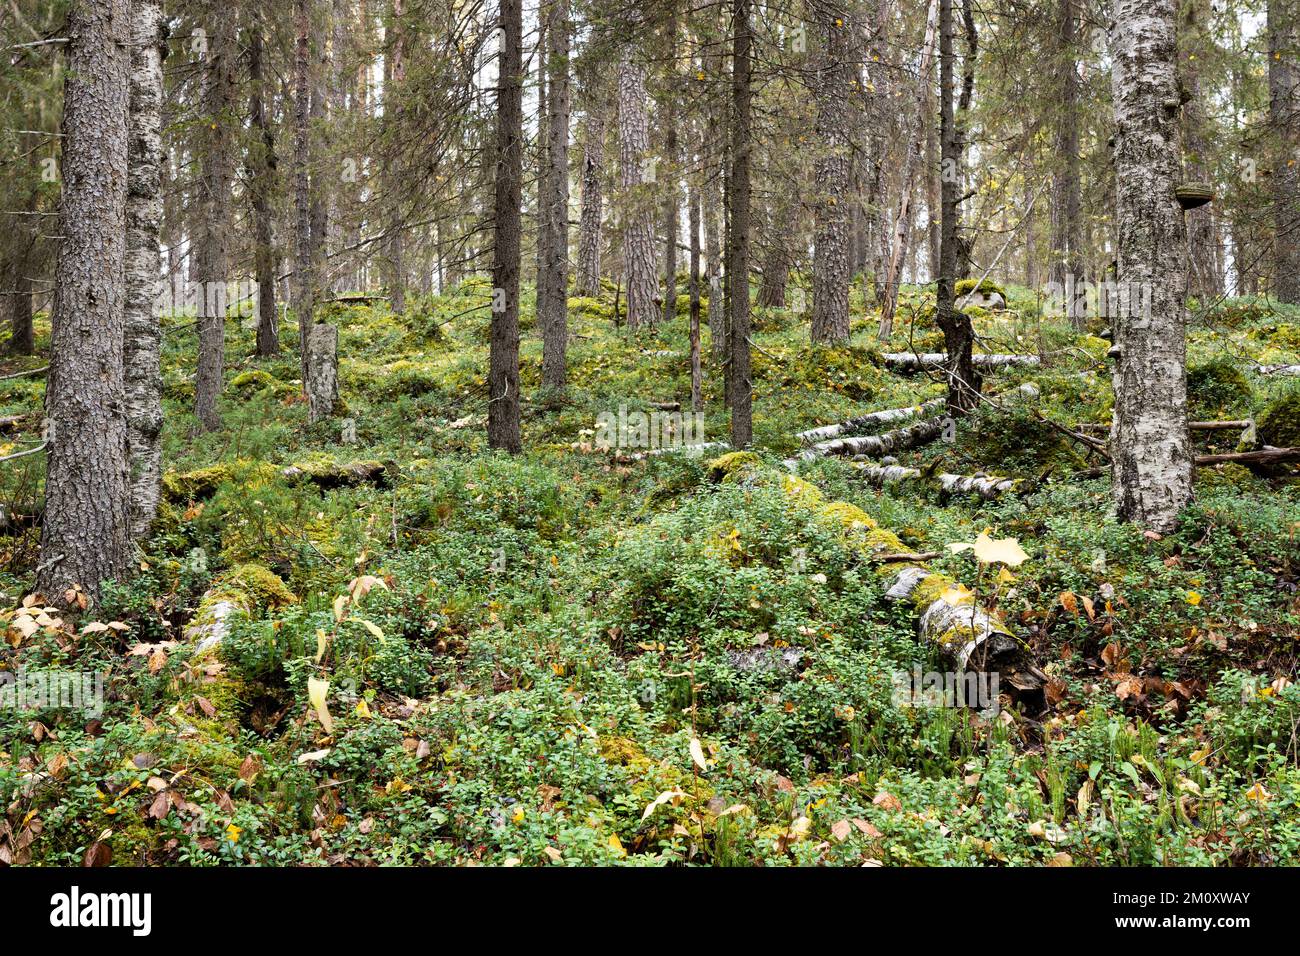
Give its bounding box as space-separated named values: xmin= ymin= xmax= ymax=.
xmin=194 ymin=1 xmax=237 ymax=431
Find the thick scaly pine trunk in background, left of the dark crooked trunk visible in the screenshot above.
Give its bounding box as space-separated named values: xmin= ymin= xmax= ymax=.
xmin=813 ymin=0 xmax=853 ymax=343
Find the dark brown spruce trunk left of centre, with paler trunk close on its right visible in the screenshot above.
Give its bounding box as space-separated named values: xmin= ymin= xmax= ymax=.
xmin=488 ymin=0 xmax=524 ymax=454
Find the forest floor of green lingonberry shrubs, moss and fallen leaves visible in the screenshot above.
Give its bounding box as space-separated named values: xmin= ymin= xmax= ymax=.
xmin=0 ymin=280 xmax=1300 ymax=865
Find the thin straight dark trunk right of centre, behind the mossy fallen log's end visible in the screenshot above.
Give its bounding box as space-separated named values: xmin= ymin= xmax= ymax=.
xmin=727 ymin=0 xmax=754 ymax=449
